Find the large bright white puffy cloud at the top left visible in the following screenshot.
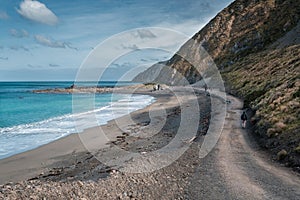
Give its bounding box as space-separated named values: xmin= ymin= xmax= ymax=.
xmin=17 ymin=0 xmax=58 ymax=25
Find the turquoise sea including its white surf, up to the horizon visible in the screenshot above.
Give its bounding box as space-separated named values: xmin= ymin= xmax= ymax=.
xmin=0 ymin=82 xmax=155 ymax=159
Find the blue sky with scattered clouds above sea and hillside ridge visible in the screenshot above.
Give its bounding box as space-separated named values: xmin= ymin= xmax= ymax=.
xmin=0 ymin=0 xmax=232 ymax=81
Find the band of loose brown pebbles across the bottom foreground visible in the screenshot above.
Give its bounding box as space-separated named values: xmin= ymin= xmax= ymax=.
xmin=0 ymin=107 xmax=209 ymax=200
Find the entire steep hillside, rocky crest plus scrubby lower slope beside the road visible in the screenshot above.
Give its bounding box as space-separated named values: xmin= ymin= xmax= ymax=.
xmin=135 ymin=0 xmax=300 ymax=167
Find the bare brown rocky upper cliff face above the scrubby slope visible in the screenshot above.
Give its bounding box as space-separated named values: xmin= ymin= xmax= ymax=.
xmin=137 ymin=0 xmax=300 ymax=84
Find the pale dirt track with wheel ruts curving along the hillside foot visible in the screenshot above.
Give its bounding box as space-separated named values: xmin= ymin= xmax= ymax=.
xmin=188 ymin=91 xmax=300 ymax=200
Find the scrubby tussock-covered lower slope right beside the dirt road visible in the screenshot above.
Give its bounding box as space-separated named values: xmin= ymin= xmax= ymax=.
xmin=223 ymin=45 xmax=300 ymax=167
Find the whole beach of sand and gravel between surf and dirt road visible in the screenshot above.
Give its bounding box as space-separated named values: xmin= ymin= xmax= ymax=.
xmin=0 ymin=87 xmax=213 ymax=199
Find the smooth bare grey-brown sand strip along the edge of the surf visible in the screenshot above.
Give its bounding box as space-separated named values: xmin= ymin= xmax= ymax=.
xmin=0 ymin=87 xmax=183 ymax=184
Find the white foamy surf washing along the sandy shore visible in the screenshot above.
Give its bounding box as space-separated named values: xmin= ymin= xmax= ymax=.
xmin=0 ymin=94 xmax=155 ymax=159
